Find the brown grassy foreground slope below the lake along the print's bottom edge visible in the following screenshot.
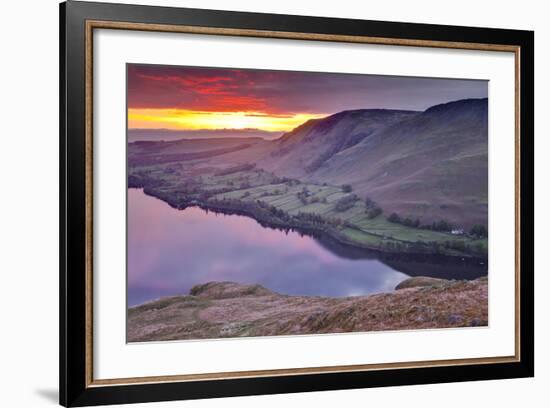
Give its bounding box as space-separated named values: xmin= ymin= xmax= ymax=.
xmin=128 ymin=278 xmax=488 ymax=342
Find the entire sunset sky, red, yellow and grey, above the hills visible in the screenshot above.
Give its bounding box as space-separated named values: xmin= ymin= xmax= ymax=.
xmin=127 ymin=64 xmax=488 ymax=132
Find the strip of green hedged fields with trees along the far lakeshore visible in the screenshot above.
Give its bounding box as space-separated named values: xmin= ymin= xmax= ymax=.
xmin=129 ymin=163 xmax=487 ymax=256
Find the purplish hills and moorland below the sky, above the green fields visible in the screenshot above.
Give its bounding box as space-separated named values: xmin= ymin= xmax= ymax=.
xmin=129 ymin=98 xmax=488 ymax=230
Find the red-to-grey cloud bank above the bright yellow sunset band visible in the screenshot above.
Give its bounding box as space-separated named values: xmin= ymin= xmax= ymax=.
xmin=127 ymin=64 xmax=487 ymax=116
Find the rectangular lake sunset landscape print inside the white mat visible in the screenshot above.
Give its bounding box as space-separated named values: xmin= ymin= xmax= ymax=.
xmin=127 ymin=64 xmax=489 ymax=342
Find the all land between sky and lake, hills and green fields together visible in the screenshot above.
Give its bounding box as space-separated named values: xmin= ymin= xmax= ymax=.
xmin=128 ymin=99 xmax=487 ymax=259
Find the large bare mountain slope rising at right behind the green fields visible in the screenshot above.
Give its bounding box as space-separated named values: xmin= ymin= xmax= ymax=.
xmin=266 ymin=99 xmax=488 ymax=228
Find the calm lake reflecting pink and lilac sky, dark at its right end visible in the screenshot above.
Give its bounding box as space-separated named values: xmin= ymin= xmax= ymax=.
xmin=128 ymin=189 xmax=487 ymax=306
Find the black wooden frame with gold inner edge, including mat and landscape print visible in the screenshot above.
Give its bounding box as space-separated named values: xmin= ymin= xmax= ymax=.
xmin=60 ymin=1 xmax=534 ymax=406
